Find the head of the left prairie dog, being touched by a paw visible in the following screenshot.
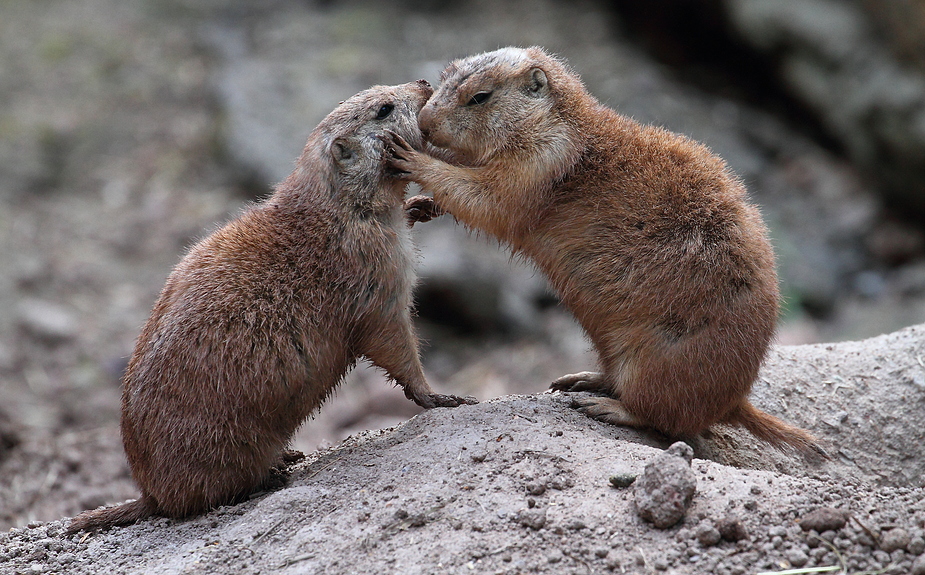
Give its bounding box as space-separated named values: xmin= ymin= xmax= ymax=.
xmin=290 ymin=80 xmax=433 ymax=211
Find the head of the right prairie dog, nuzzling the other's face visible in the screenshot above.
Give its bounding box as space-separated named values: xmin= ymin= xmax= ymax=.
xmin=419 ymin=47 xmax=585 ymax=165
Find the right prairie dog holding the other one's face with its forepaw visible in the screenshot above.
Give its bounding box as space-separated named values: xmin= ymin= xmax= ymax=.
xmin=392 ymin=47 xmax=821 ymax=453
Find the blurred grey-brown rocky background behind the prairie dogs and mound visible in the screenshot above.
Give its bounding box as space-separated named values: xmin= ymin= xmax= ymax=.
xmin=0 ymin=0 xmax=925 ymax=527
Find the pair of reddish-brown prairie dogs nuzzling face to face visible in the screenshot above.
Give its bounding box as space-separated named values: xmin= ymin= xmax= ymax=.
xmin=68 ymin=47 xmax=825 ymax=533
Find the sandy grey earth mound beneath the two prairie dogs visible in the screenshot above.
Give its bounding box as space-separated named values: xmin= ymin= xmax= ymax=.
xmin=0 ymin=326 xmax=925 ymax=574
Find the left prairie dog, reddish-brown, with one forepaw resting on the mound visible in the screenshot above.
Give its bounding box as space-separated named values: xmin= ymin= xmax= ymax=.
xmin=68 ymin=80 xmax=474 ymax=533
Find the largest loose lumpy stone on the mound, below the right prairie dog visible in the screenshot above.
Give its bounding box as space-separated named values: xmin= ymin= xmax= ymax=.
xmin=633 ymin=441 xmax=697 ymax=529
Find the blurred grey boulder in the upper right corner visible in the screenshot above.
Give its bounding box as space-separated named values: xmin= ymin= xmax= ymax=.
xmin=724 ymin=0 xmax=925 ymax=225
